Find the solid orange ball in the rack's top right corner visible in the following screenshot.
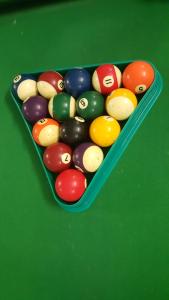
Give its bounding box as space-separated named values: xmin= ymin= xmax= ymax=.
xmin=122 ymin=61 xmax=155 ymax=94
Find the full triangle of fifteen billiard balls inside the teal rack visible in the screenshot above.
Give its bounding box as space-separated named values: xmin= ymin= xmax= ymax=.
xmin=12 ymin=61 xmax=154 ymax=203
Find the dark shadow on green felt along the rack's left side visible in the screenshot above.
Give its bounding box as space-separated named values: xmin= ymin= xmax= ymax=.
xmin=5 ymin=91 xmax=60 ymax=209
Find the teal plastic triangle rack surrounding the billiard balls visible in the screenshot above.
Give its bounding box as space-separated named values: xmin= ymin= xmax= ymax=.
xmin=11 ymin=61 xmax=163 ymax=212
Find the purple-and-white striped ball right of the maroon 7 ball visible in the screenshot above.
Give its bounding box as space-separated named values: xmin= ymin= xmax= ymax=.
xmin=73 ymin=142 xmax=104 ymax=173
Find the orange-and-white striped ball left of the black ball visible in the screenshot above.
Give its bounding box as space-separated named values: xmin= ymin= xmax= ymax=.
xmin=32 ymin=118 xmax=59 ymax=147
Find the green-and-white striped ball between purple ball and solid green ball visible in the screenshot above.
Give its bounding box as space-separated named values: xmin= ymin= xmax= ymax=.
xmin=48 ymin=92 xmax=76 ymax=122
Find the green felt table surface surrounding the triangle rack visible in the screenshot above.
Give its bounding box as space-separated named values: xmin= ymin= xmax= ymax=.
xmin=0 ymin=0 xmax=169 ymax=300
